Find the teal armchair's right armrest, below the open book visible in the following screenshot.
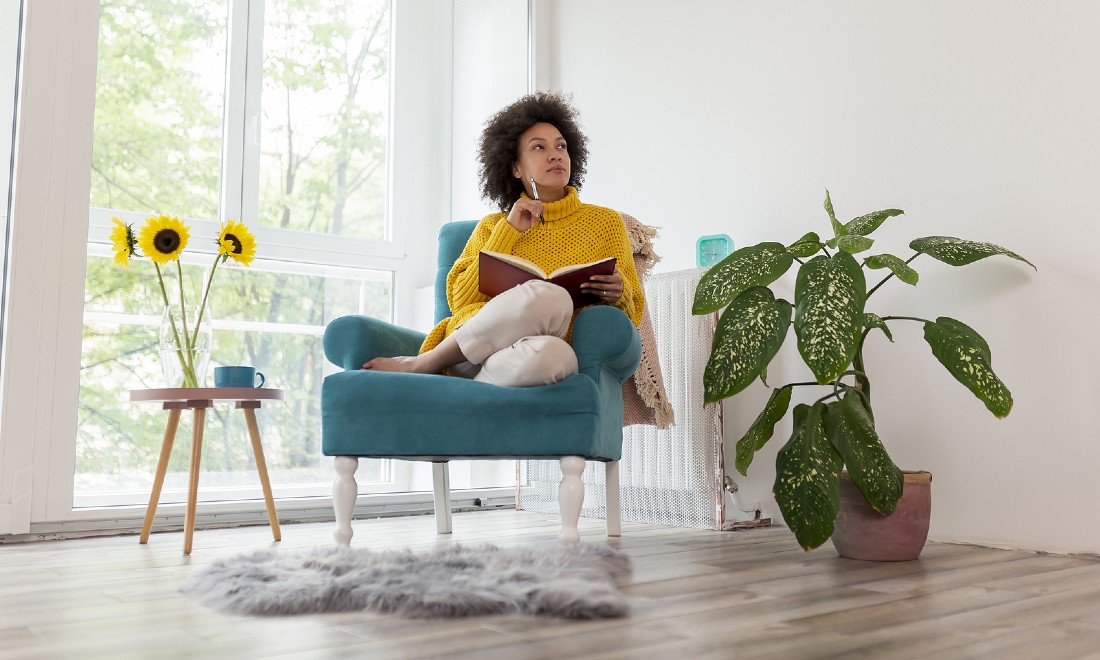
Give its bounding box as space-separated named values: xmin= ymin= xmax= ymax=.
xmin=573 ymin=305 xmax=641 ymax=383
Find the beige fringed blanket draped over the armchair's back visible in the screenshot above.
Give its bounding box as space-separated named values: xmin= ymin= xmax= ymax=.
xmin=622 ymin=213 xmax=675 ymax=429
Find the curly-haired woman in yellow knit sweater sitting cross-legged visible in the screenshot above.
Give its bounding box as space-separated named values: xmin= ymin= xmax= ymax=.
xmin=363 ymin=92 xmax=645 ymax=386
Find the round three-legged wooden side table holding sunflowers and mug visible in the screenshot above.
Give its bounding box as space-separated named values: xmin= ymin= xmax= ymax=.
xmin=130 ymin=387 xmax=283 ymax=554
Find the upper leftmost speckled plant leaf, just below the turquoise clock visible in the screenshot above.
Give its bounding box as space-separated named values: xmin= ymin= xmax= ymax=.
xmin=691 ymin=243 xmax=794 ymax=315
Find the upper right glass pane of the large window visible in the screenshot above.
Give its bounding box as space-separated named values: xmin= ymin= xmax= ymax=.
xmin=257 ymin=0 xmax=389 ymax=240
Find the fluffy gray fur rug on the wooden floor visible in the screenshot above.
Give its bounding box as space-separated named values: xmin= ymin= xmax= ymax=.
xmin=180 ymin=545 xmax=630 ymax=619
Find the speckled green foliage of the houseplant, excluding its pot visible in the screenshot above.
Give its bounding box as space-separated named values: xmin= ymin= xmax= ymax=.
xmin=692 ymin=190 xmax=1035 ymax=550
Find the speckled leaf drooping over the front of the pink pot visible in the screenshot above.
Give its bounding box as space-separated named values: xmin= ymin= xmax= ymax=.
xmin=825 ymin=394 xmax=904 ymax=516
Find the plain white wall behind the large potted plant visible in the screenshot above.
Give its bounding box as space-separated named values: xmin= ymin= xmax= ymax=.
xmin=542 ymin=0 xmax=1100 ymax=552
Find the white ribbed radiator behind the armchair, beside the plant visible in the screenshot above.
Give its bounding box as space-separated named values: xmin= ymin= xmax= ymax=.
xmin=516 ymin=268 xmax=726 ymax=529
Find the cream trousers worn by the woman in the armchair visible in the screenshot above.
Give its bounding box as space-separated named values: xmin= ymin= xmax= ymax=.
xmin=448 ymin=279 xmax=578 ymax=387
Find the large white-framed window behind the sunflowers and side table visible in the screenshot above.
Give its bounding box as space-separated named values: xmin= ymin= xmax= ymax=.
xmin=74 ymin=0 xmax=391 ymax=506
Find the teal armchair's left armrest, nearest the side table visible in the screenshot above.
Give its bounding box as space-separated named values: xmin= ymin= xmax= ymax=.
xmin=325 ymin=316 xmax=425 ymax=371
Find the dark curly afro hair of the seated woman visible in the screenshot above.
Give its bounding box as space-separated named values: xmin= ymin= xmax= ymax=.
xmin=477 ymin=91 xmax=589 ymax=211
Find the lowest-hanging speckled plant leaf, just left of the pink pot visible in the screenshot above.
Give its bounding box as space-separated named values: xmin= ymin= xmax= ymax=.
xmin=774 ymin=403 xmax=843 ymax=551
